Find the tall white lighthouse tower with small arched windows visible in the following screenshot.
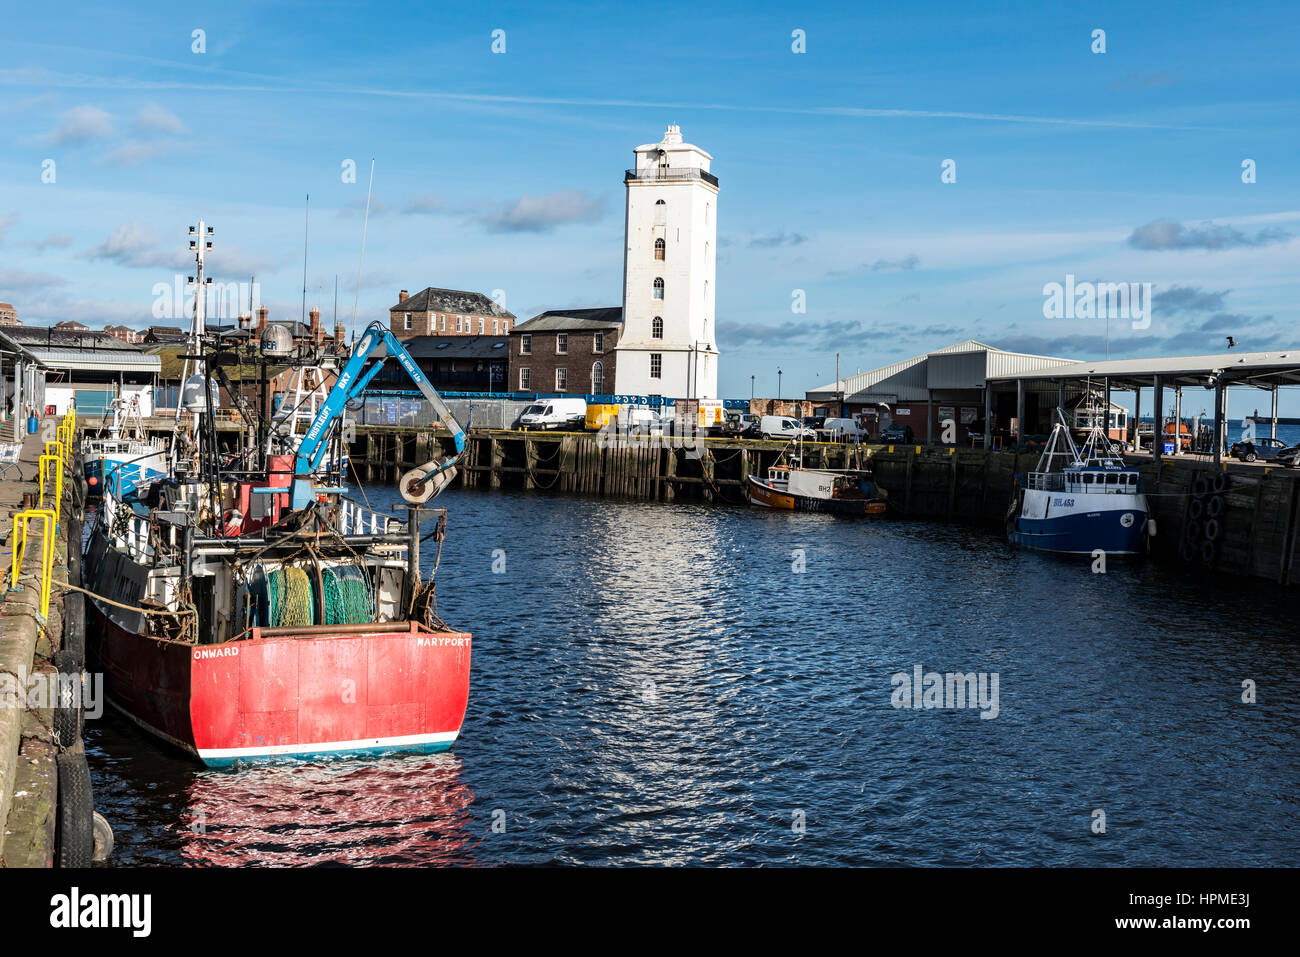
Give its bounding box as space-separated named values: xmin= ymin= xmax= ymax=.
xmin=615 ymin=126 xmax=718 ymax=399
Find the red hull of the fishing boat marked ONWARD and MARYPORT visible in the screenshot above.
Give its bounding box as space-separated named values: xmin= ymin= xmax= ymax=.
xmin=87 ymin=601 xmax=471 ymax=767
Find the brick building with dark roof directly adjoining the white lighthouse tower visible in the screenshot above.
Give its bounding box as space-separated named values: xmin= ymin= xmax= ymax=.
xmin=510 ymin=306 xmax=623 ymax=395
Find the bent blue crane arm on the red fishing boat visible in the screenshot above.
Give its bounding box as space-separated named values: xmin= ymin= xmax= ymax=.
xmin=294 ymin=321 xmax=465 ymax=507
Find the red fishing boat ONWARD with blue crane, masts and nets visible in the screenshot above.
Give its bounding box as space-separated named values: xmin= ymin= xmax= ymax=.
xmin=82 ymin=222 xmax=471 ymax=767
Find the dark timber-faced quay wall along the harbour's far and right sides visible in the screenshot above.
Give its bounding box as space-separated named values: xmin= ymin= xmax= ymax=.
xmin=350 ymin=426 xmax=1300 ymax=584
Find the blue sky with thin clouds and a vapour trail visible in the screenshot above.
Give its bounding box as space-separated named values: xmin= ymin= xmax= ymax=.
xmin=0 ymin=1 xmax=1300 ymax=415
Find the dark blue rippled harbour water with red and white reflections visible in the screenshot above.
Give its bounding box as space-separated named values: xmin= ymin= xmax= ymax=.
xmin=87 ymin=490 xmax=1300 ymax=866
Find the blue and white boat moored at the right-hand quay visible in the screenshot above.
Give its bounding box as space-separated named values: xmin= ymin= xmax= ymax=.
xmin=1006 ymin=413 xmax=1156 ymax=555
